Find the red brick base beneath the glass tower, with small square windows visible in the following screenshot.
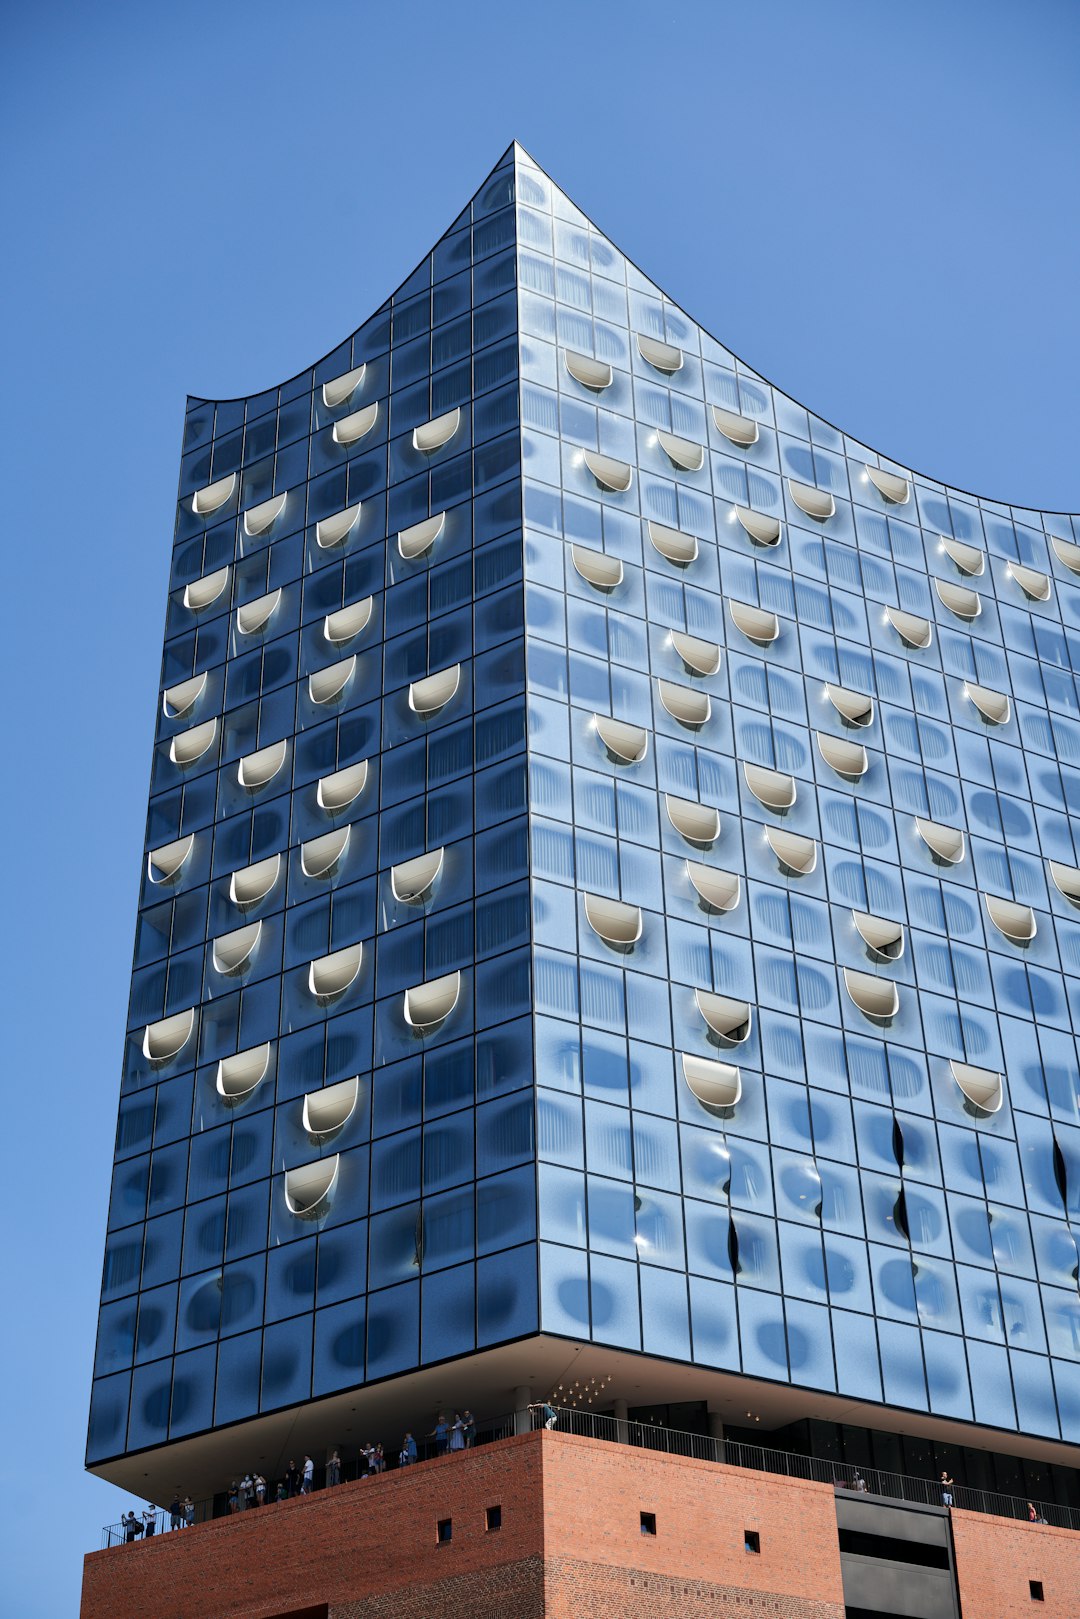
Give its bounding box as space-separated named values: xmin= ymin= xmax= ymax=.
xmin=81 ymin=1431 xmax=1080 ymax=1619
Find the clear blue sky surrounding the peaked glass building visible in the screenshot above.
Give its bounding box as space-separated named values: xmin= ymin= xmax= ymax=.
xmin=0 ymin=0 xmax=1080 ymax=1619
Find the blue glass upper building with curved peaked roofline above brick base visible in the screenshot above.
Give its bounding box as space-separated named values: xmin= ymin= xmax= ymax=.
xmin=87 ymin=146 xmax=1080 ymax=1494
